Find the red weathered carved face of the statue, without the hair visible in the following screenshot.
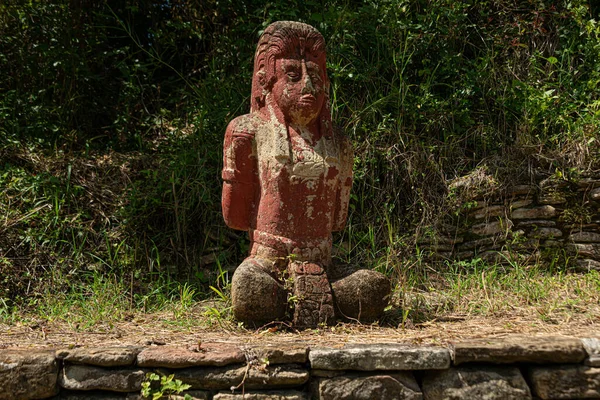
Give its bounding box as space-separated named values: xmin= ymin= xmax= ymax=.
xmin=272 ymin=54 xmax=325 ymax=126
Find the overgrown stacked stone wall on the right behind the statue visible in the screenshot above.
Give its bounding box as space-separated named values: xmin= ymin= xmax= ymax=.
xmin=419 ymin=176 xmax=600 ymax=271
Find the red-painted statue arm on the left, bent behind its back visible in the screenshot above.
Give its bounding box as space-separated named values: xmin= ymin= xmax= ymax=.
xmin=221 ymin=115 xmax=258 ymax=231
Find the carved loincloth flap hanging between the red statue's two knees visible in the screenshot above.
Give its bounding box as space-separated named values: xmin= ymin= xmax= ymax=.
xmin=289 ymin=262 xmax=335 ymax=328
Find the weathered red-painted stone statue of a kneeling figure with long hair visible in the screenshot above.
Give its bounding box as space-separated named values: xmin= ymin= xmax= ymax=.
xmin=222 ymin=21 xmax=390 ymax=327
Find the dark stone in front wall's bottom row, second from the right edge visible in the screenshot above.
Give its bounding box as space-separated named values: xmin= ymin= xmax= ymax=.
xmin=421 ymin=367 xmax=531 ymax=400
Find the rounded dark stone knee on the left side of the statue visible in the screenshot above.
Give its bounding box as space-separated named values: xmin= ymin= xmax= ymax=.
xmin=231 ymin=257 xmax=287 ymax=326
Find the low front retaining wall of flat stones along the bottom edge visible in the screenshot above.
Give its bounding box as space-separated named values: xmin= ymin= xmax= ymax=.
xmin=0 ymin=337 xmax=600 ymax=400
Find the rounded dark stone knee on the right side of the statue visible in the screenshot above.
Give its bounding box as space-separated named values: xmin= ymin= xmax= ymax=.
xmin=331 ymin=269 xmax=391 ymax=322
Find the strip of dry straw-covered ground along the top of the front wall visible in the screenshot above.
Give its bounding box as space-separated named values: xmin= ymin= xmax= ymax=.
xmin=0 ymin=315 xmax=600 ymax=349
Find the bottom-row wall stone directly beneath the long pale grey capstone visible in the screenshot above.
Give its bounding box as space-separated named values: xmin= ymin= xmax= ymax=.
xmin=314 ymin=372 xmax=423 ymax=400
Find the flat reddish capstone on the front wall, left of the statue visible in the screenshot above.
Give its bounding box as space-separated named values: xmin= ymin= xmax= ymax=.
xmin=137 ymin=343 xmax=246 ymax=368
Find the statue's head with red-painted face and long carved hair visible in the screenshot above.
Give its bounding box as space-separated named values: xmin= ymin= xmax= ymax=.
xmin=251 ymin=21 xmax=331 ymax=135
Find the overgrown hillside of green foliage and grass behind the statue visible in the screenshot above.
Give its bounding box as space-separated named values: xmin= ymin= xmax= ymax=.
xmin=0 ymin=0 xmax=600 ymax=304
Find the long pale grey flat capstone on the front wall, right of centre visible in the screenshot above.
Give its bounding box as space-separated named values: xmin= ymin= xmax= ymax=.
xmin=308 ymin=344 xmax=450 ymax=371
